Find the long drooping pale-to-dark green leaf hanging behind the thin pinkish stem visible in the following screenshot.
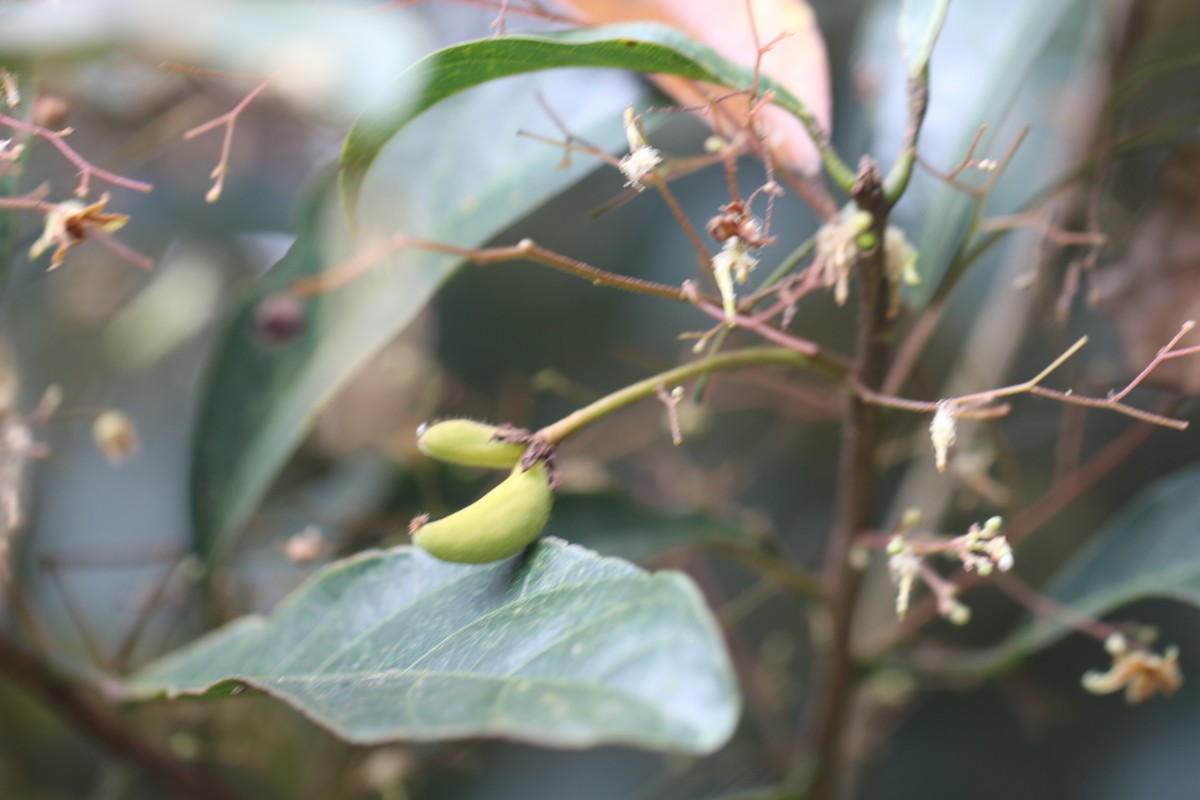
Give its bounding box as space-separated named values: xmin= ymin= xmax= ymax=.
xmin=192 ymin=73 xmax=637 ymax=564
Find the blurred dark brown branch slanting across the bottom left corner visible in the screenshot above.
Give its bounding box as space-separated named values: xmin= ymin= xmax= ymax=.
xmin=0 ymin=633 xmax=242 ymax=800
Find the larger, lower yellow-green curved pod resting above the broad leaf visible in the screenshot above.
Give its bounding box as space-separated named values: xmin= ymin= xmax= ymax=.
xmin=413 ymin=462 xmax=553 ymax=564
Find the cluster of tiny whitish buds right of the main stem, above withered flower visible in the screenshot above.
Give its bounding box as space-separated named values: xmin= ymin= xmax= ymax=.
xmin=887 ymin=511 xmax=1013 ymax=625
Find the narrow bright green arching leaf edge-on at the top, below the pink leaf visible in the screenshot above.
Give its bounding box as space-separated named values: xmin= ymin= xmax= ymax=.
xmin=342 ymin=23 xmax=854 ymax=212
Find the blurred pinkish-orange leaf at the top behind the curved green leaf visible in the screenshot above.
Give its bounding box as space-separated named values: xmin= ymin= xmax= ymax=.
xmin=554 ymin=0 xmax=833 ymax=174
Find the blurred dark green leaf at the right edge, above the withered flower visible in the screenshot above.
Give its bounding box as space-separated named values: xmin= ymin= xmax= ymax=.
xmin=989 ymin=467 xmax=1200 ymax=668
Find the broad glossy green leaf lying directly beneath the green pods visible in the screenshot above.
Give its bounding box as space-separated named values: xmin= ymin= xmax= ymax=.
xmin=130 ymin=539 xmax=740 ymax=753
